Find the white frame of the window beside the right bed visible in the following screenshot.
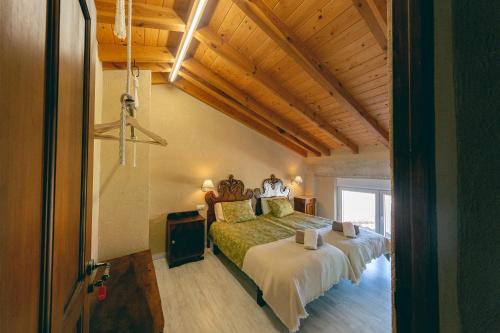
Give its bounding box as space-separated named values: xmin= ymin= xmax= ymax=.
xmin=336 ymin=178 xmax=392 ymax=237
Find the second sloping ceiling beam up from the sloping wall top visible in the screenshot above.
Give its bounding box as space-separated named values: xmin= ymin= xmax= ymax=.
xmin=179 ymin=68 xmax=321 ymax=155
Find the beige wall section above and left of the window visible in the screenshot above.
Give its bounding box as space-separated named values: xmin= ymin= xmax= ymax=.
xmin=307 ymin=148 xmax=391 ymax=219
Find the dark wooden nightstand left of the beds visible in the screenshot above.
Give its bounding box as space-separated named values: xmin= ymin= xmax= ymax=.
xmin=165 ymin=211 xmax=205 ymax=268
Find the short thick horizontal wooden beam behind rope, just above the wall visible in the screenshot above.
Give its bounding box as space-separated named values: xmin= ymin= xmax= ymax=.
xmin=98 ymin=43 xmax=174 ymax=63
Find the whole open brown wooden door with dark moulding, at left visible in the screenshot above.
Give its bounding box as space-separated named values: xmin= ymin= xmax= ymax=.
xmin=0 ymin=0 xmax=95 ymax=333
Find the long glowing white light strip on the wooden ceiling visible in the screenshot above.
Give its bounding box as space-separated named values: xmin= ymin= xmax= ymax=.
xmin=168 ymin=0 xmax=208 ymax=82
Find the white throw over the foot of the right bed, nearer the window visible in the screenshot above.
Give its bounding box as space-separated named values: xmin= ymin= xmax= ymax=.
xmin=320 ymin=228 xmax=391 ymax=283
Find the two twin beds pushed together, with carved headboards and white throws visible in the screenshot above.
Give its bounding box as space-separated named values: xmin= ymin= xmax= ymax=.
xmin=205 ymin=175 xmax=390 ymax=332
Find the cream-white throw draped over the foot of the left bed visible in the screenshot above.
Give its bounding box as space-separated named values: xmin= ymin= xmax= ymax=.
xmin=242 ymin=237 xmax=355 ymax=332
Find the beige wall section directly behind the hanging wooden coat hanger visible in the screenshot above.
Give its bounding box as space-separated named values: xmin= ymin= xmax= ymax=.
xmin=99 ymin=71 xmax=151 ymax=259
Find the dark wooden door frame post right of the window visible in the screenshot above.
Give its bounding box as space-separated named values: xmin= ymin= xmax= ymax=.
xmin=392 ymin=0 xmax=439 ymax=332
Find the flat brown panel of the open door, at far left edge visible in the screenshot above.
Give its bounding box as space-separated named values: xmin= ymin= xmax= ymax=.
xmin=0 ymin=0 xmax=47 ymax=333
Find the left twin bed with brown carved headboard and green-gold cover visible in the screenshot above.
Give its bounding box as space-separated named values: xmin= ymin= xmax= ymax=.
xmin=205 ymin=176 xmax=354 ymax=332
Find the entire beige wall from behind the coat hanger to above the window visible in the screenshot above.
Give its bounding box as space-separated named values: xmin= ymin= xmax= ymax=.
xmin=94 ymin=80 xmax=390 ymax=259
